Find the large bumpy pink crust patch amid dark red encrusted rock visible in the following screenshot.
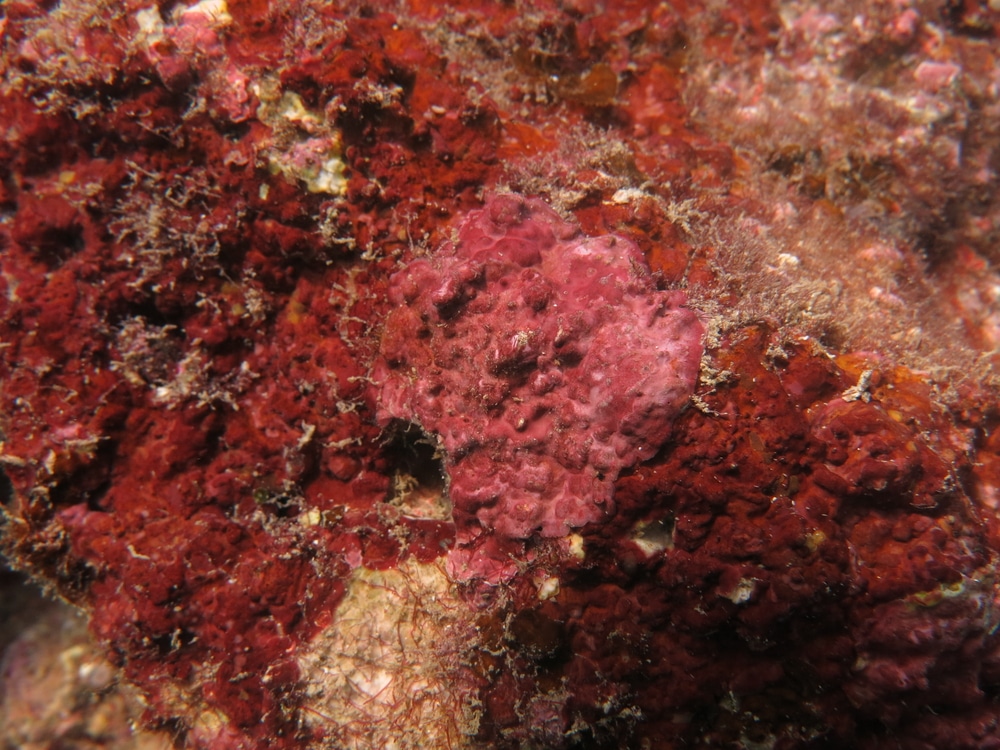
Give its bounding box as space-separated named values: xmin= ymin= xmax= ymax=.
xmin=375 ymin=195 xmax=703 ymax=542
